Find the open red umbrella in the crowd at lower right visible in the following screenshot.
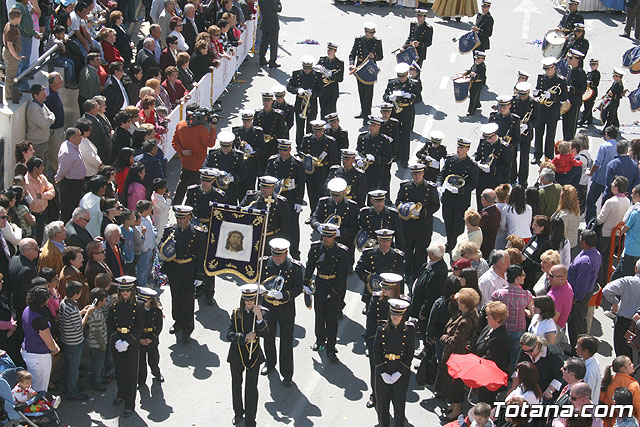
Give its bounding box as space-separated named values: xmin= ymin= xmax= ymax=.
xmin=447 ymin=353 xmax=509 ymax=391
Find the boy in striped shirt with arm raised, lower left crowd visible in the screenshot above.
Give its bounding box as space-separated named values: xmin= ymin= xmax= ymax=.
xmin=58 ymin=280 xmax=95 ymax=400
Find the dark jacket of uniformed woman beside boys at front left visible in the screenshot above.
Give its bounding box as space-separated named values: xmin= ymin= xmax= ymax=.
xmin=107 ymin=301 xmax=145 ymax=346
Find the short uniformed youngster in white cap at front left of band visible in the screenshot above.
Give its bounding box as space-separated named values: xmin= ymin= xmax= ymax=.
xmin=138 ymin=287 xmax=164 ymax=386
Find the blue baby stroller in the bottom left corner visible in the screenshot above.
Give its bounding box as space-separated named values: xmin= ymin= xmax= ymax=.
xmin=0 ymin=352 xmax=63 ymax=427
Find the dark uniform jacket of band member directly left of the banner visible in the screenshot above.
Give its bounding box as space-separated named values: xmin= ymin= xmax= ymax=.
xmin=160 ymin=224 xmax=207 ymax=283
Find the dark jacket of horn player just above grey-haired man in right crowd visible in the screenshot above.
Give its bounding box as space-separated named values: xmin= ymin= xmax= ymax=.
xmin=396 ymin=180 xmax=440 ymax=231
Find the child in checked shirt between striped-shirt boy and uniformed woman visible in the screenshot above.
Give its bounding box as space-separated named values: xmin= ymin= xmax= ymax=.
xmin=87 ymin=288 xmax=107 ymax=391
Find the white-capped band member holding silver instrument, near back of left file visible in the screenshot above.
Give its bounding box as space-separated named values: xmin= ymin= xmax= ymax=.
xmin=287 ymin=55 xmax=324 ymax=147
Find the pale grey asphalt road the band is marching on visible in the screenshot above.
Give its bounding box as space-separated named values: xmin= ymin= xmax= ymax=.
xmin=59 ymin=0 xmax=636 ymax=427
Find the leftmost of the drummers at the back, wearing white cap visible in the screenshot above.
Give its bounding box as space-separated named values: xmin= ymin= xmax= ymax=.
xmin=349 ymin=22 xmax=383 ymax=121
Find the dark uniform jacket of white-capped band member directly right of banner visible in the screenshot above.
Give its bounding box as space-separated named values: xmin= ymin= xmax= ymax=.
xmin=260 ymin=257 xmax=302 ymax=313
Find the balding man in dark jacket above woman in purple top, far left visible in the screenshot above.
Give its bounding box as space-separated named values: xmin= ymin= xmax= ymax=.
xmin=8 ymin=239 xmax=40 ymax=322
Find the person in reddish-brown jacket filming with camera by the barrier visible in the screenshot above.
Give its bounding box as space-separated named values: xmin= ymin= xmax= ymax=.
xmin=171 ymin=104 xmax=217 ymax=205
